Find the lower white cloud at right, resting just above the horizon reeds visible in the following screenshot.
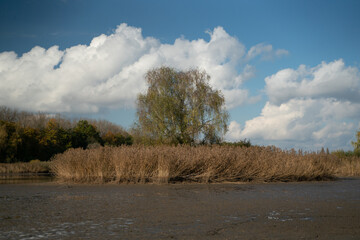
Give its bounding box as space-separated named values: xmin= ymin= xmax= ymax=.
xmin=226 ymin=99 xmax=360 ymax=149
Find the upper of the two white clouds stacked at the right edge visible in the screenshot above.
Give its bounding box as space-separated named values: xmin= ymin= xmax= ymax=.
xmin=265 ymin=59 xmax=360 ymax=104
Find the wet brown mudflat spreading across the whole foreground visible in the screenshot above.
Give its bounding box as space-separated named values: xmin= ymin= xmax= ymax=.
xmin=0 ymin=178 xmax=360 ymax=239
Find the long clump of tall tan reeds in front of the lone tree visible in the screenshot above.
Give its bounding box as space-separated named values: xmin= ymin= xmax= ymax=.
xmin=51 ymin=146 xmax=352 ymax=183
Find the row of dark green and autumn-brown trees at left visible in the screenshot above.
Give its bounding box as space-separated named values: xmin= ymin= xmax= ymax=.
xmin=0 ymin=106 xmax=133 ymax=162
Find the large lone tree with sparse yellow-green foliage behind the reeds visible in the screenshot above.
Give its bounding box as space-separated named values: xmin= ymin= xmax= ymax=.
xmin=134 ymin=67 xmax=229 ymax=144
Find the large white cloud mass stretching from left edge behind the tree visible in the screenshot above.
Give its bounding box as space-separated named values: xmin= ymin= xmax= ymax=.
xmin=0 ymin=24 xmax=282 ymax=113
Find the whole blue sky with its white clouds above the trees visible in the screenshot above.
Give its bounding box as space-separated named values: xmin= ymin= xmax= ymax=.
xmin=0 ymin=0 xmax=360 ymax=150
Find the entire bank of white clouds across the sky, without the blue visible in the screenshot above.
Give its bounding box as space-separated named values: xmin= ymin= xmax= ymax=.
xmin=0 ymin=23 xmax=360 ymax=149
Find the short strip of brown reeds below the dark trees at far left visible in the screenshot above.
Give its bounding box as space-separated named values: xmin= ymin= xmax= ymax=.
xmin=0 ymin=160 xmax=50 ymax=175
